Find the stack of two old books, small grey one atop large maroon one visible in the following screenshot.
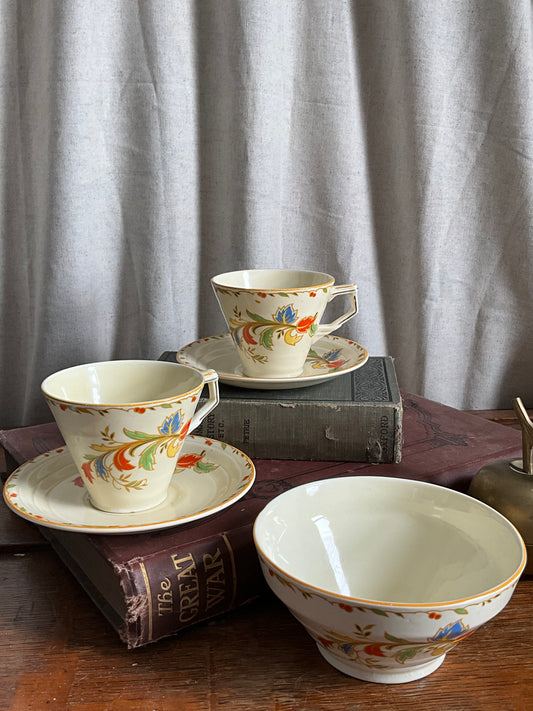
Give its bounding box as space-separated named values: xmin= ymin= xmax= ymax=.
xmin=0 ymin=352 xmax=521 ymax=648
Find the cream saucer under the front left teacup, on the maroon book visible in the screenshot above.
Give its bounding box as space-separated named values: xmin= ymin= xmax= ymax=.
xmin=4 ymin=435 xmax=255 ymax=534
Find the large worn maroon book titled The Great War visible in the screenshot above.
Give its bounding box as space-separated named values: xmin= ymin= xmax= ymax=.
xmin=0 ymin=394 xmax=522 ymax=648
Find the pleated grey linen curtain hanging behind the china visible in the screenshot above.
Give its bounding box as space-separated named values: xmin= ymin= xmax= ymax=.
xmin=0 ymin=0 xmax=533 ymax=426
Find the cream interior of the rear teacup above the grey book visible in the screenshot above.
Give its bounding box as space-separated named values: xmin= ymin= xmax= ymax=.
xmin=213 ymin=269 xmax=334 ymax=291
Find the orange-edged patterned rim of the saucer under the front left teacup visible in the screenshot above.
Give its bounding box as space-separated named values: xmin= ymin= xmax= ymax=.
xmin=3 ymin=434 xmax=257 ymax=535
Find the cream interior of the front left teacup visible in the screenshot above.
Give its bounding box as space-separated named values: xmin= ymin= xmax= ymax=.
xmin=42 ymin=360 xmax=203 ymax=405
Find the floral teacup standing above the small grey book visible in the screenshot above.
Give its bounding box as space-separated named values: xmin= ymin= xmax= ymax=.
xmin=211 ymin=269 xmax=357 ymax=378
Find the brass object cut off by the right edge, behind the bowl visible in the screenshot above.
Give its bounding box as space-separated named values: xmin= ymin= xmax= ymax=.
xmin=468 ymin=397 xmax=533 ymax=575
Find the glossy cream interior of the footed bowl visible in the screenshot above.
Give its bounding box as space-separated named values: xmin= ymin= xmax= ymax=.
xmin=254 ymin=476 xmax=524 ymax=605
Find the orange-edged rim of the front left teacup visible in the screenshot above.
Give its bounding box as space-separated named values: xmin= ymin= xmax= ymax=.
xmin=41 ymin=358 xmax=205 ymax=410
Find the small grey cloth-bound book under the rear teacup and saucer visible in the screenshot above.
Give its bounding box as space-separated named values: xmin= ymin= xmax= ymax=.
xmin=160 ymin=351 xmax=403 ymax=463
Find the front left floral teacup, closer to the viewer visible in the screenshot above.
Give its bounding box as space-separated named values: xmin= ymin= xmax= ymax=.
xmin=41 ymin=360 xmax=219 ymax=513
